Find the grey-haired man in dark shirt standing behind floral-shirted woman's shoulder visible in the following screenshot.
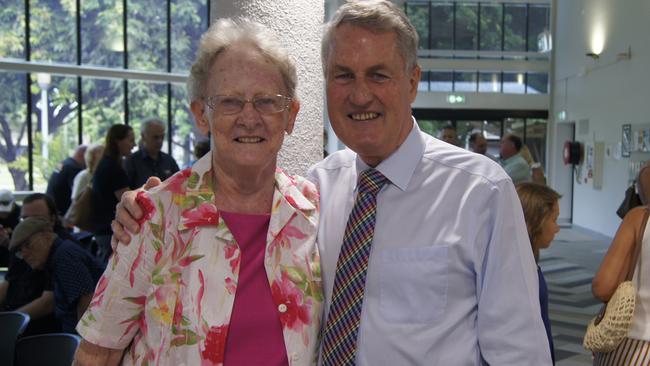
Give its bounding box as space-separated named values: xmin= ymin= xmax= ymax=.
xmin=124 ymin=118 xmax=178 ymax=188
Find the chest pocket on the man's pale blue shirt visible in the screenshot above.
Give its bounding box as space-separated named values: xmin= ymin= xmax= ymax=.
xmin=379 ymin=246 xmax=449 ymax=323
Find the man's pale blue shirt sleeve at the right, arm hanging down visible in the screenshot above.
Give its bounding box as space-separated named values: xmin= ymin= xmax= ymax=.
xmin=477 ymin=180 xmax=552 ymax=366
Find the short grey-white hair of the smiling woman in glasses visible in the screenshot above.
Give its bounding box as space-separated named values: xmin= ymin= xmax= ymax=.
xmin=187 ymin=18 xmax=298 ymax=102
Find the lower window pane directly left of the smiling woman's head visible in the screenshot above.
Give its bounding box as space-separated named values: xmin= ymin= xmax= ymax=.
xmin=172 ymin=84 xmax=207 ymax=169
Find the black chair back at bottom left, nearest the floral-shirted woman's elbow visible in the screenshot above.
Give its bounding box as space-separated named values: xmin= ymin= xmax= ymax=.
xmin=14 ymin=333 xmax=81 ymax=366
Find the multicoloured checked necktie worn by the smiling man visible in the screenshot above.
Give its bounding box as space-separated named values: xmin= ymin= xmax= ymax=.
xmin=322 ymin=169 xmax=388 ymax=366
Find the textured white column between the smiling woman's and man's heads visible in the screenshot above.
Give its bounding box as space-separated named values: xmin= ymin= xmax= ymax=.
xmin=210 ymin=0 xmax=325 ymax=175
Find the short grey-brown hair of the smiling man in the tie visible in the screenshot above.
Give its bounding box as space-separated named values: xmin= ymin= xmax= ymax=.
xmin=321 ymin=0 xmax=418 ymax=75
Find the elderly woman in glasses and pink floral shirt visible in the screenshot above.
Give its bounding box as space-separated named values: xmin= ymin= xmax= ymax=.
xmin=76 ymin=19 xmax=322 ymax=365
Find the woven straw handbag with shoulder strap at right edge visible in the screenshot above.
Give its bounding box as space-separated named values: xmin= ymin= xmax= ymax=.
xmin=582 ymin=210 xmax=650 ymax=352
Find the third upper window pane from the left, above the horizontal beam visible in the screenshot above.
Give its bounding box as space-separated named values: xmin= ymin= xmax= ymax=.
xmin=81 ymin=0 xmax=124 ymax=67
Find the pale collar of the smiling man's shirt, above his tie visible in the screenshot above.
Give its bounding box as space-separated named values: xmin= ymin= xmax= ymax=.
xmin=356 ymin=117 xmax=425 ymax=191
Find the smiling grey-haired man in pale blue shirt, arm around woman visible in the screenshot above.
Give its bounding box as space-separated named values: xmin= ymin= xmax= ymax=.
xmin=114 ymin=0 xmax=551 ymax=366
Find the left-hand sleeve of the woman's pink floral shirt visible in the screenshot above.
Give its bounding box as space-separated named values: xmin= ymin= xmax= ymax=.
xmin=77 ymin=193 xmax=164 ymax=349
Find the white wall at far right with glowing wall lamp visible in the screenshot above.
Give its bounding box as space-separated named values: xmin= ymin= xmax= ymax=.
xmin=550 ymin=0 xmax=650 ymax=236
